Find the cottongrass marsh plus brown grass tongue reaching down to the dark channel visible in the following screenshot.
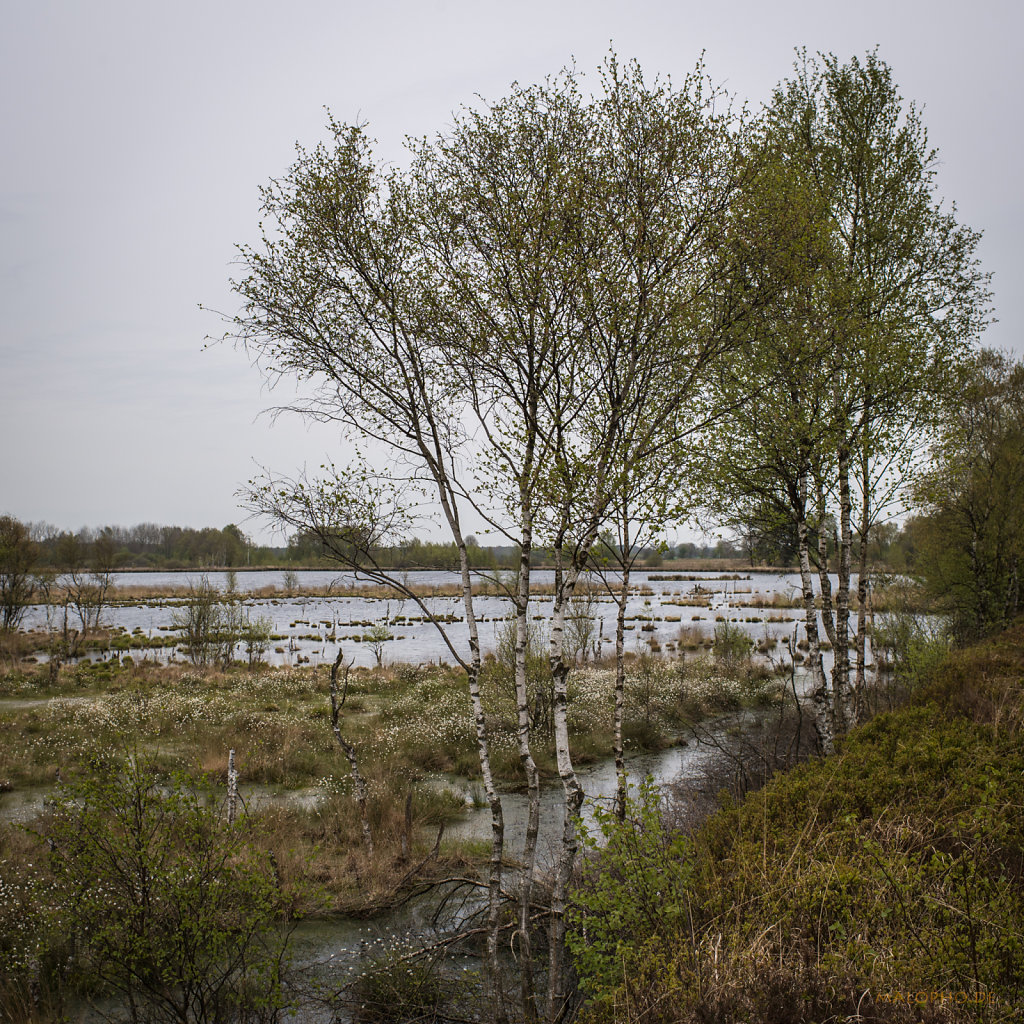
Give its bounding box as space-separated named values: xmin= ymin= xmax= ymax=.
xmin=0 ymin=638 xmax=774 ymax=909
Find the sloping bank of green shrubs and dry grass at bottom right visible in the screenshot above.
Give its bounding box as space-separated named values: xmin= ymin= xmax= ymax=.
xmin=574 ymin=624 xmax=1024 ymax=1024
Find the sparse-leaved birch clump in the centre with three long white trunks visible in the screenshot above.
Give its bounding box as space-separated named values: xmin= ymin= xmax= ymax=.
xmin=232 ymin=58 xmax=750 ymax=1020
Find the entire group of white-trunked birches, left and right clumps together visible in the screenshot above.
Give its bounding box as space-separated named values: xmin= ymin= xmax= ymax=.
xmin=222 ymin=53 xmax=988 ymax=1022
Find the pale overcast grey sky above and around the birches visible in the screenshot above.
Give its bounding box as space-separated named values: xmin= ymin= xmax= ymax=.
xmin=0 ymin=0 xmax=1024 ymax=544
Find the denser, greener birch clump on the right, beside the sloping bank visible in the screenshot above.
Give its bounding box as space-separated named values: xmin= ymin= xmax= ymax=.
xmin=712 ymin=52 xmax=988 ymax=745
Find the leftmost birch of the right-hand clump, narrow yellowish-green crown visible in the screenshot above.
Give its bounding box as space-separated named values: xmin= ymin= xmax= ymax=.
xmin=705 ymin=123 xmax=836 ymax=753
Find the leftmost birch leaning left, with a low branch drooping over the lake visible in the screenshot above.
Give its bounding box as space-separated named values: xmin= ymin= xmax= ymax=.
xmin=229 ymin=121 xmax=504 ymax=1020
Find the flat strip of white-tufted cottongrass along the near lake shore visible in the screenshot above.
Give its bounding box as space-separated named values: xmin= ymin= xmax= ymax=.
xmin=0 ymin=638 xmax=782 ymax=788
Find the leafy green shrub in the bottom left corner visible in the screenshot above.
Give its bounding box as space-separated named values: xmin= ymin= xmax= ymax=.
xmin=30 ymin=753 xmax=296 ymax=1024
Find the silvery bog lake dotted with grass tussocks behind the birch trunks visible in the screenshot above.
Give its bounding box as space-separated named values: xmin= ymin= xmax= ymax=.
xmin=23 ymin=569 xmax=835 ymax=666
